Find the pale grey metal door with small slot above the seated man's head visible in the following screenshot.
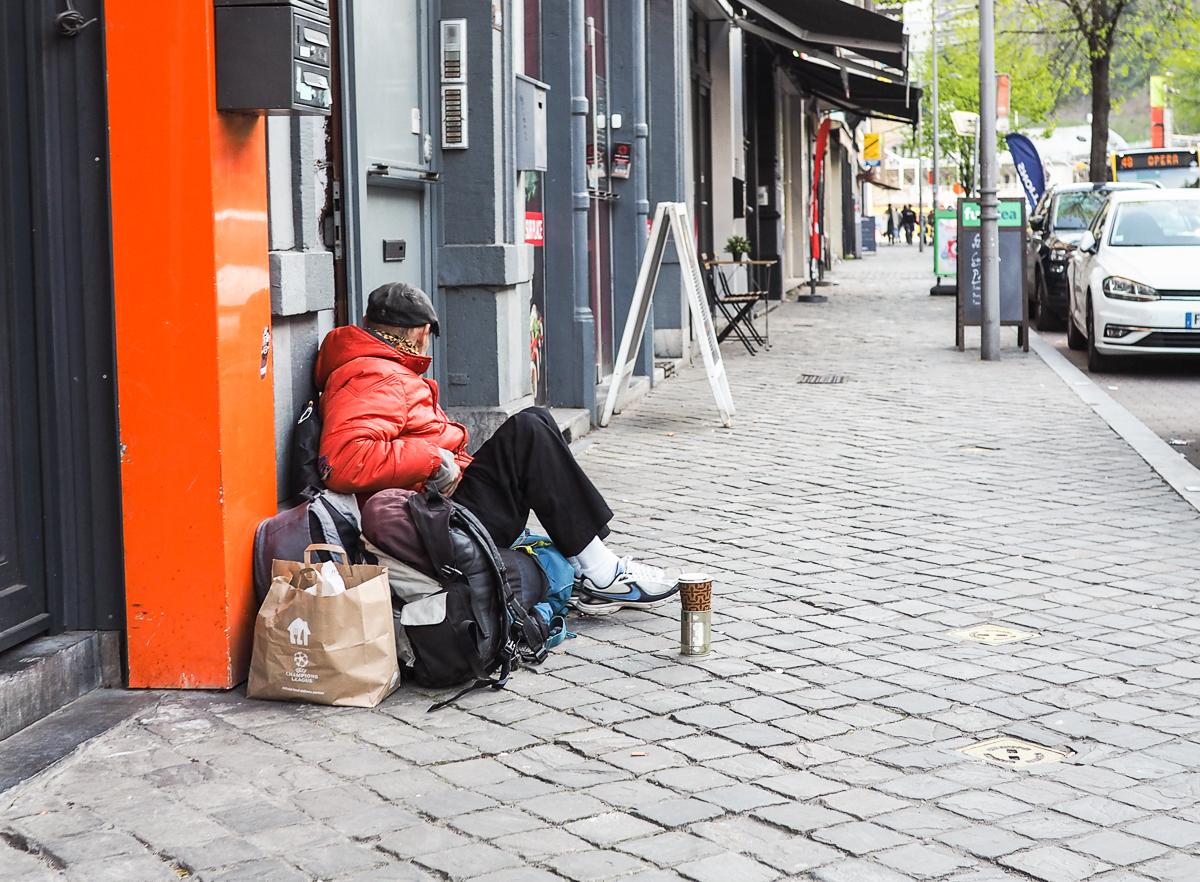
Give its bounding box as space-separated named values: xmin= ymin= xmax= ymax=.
xmin=343 ymin=0 xmax=436 ymax=320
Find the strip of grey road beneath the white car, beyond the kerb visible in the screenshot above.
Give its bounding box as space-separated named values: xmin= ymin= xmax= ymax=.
xmin=1042 ymin=332 xmax=1200 ymax=467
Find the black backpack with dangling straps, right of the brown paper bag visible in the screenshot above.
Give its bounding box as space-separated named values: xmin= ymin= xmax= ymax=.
xmin=404 ymin=490 xmax=548 ymax=712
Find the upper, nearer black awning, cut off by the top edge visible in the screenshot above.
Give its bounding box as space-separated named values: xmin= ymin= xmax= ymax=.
xmin=737 ymin=0 xmax=907 ymax=71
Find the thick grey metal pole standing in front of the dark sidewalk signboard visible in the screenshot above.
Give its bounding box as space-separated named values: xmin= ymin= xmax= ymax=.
xmin=978 ymin=0 xmax=1000 ymax=361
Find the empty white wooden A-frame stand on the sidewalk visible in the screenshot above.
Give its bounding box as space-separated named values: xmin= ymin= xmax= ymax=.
xmin=600 ymin=202 xmax=734 ymax=428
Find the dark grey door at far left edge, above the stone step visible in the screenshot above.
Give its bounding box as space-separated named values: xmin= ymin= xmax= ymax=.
xmin=0 ymin=4 xmax=50 ymax=650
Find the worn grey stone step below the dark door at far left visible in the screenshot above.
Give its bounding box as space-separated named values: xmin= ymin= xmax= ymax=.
xmin=0 ymin=631 xmax=121 ymax=740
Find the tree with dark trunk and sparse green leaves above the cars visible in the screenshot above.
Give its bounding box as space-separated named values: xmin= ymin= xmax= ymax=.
xmin=1021 ymin=0 xmax=1193 ymax=181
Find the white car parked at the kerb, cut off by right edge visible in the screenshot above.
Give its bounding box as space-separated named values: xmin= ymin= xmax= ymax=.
xmin=1067 ymin=190 xmax=1200 ymax=371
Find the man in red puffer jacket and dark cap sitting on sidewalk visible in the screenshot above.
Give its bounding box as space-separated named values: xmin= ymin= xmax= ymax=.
xmin=317 ymin=282 xmax=677 ymax=613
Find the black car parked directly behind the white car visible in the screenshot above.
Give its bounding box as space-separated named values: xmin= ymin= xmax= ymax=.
xmin=1025 ymin=181 xmax=1154 ymax=331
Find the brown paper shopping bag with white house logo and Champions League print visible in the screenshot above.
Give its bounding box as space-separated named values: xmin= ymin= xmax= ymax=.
xmin=246 ymin=545 xmax=400 ymax=708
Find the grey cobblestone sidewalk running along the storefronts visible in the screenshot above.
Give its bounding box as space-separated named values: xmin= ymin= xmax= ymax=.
xmin=0 ymin=244 xmax=1200 ymax=882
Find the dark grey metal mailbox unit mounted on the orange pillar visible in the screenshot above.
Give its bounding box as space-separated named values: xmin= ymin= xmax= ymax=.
xmin=215 ymin=0 xmax=334 ymax=115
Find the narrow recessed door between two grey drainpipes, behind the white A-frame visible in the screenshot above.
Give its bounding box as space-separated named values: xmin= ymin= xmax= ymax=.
xmin=584 ymin=0 xmax=616 ymax=382
